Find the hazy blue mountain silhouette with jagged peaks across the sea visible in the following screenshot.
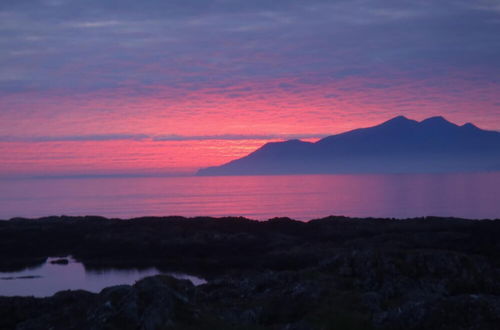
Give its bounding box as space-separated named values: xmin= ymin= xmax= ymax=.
xmin=197 ymin=116 xmax=500 ymax=175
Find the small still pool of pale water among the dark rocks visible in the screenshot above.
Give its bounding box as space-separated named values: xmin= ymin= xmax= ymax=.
xmin=0 ymin=258 xmax=206 ymax=297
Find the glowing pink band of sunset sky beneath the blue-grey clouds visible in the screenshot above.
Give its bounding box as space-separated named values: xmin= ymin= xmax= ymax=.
xmin=0 ymin=71 xmax=500 ymax=176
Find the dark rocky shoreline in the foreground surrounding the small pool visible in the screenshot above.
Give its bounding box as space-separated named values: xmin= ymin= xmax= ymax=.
xmin=0 ymin=217 xmax=500 ymax=330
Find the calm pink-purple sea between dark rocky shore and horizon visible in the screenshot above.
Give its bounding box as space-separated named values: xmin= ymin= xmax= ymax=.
xmin=0 ymin=172 xmax=500 ymax=220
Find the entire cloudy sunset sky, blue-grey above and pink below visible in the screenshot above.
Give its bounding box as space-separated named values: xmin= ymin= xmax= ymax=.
xmin=0 ymin=0 xmax=500 ymax=177
